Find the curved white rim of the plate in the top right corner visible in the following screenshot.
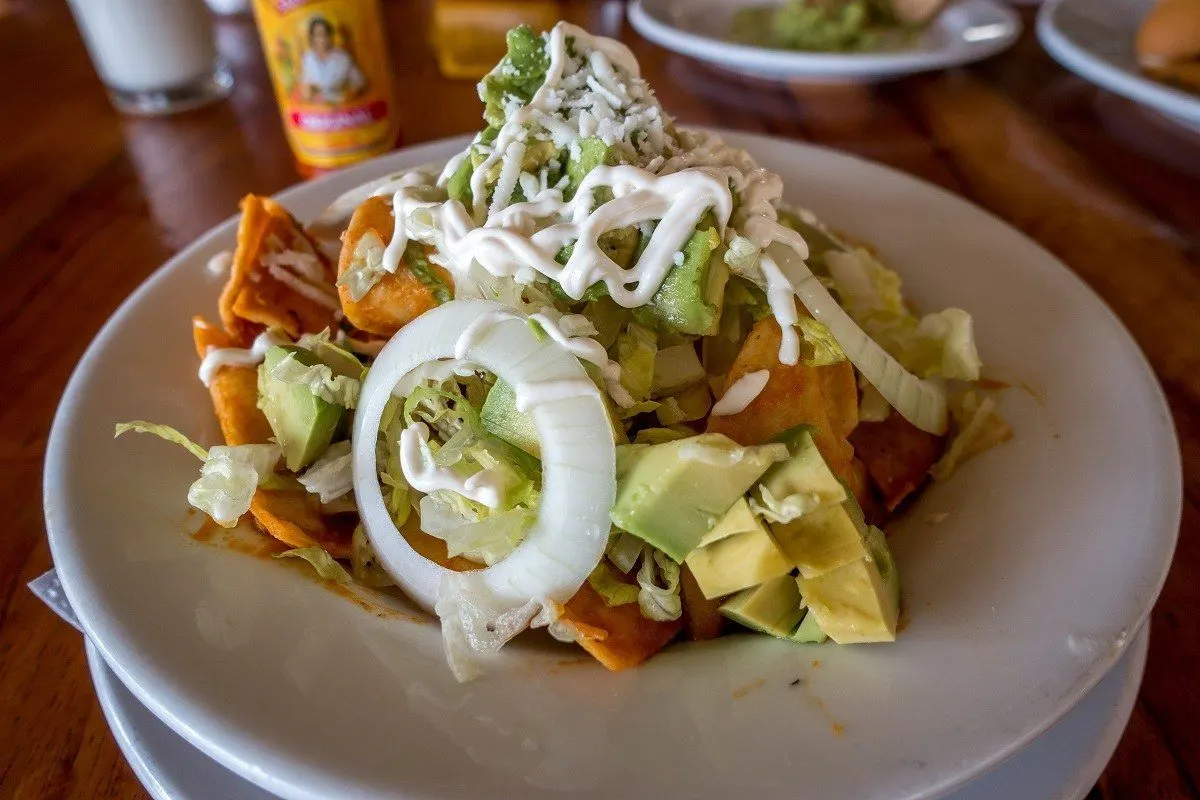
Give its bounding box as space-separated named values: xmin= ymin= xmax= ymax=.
xmin=1036 ymin=0 xmax=1200 ymax=125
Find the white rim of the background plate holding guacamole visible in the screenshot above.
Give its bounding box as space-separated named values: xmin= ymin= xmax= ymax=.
xmin=626 ymin=0 xmax=1025 ymax=80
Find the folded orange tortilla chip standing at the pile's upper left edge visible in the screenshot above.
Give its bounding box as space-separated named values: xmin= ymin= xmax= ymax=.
xmin=220 ymin=194 xmax=341 ymax=347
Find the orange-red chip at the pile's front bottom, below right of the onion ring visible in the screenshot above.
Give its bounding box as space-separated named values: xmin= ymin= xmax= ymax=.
xmin=562 ymin=573 xmax=683 ymax=672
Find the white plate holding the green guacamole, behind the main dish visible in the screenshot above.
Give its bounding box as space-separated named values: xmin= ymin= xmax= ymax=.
xmin=629 ymin=0 xmax=1021 ymax=82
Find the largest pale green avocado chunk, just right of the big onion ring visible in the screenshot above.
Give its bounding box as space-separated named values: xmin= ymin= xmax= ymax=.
xmin=612 ymin=433 xmax=779 ymax=561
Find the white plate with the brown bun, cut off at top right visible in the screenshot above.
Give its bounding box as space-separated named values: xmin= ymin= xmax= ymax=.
xmin=1038 ymin=0 xmax=1200 ymax=128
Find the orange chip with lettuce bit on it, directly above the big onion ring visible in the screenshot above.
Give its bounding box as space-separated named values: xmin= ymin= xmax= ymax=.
xmin=337 ymin=197 xmax=454 ymax=336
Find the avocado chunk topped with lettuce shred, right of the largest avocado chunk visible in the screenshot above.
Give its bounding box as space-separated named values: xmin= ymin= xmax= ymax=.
xmin=751 ymin=426 xmax=846 ymax=523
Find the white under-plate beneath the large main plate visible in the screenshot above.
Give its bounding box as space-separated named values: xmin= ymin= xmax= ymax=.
xmin=88 ymin=628 xmax=1148 ymax=800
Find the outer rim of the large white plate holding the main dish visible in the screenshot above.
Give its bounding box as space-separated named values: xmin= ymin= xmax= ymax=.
xmin=42 ymin=128 xmax=1183 ymax=800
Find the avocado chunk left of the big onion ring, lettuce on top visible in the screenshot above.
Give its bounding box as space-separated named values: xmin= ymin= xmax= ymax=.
xmin=258 ymin=345 xmax=346 ymax=473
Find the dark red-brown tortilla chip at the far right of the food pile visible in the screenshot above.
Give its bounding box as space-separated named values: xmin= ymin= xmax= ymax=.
xmin=850 ymin=411 xmax=946 ymax=511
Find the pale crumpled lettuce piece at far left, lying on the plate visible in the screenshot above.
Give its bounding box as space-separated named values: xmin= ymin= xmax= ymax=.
xmin=187 ymin=445 xmax=283 ymax=528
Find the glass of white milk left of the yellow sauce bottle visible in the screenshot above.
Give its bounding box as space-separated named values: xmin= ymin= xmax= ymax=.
xmin=70 ymin=0 xmax=233 ymax=114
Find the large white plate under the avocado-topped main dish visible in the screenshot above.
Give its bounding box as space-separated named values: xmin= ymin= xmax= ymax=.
xmin=44 ymin=134 xmax=1181 ymax=800
